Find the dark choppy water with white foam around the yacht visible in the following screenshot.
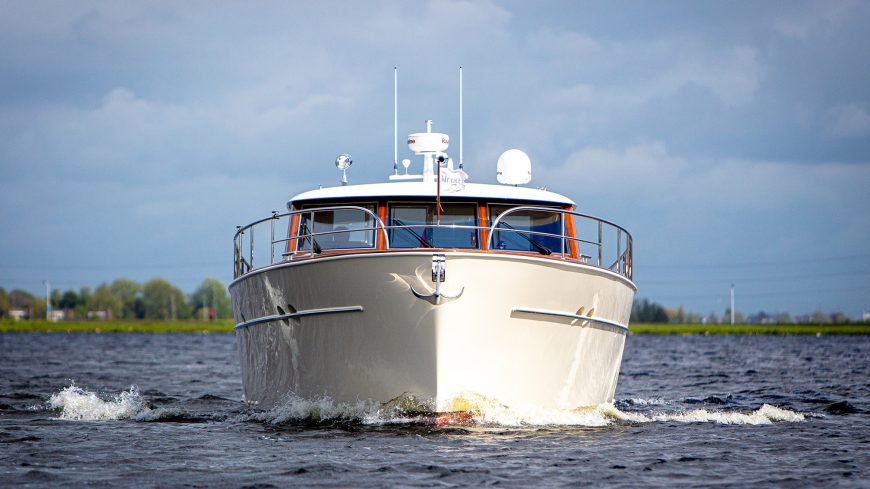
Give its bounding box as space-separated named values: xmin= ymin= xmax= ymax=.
xmin=0 ymin=334 xmax=870 ymax=487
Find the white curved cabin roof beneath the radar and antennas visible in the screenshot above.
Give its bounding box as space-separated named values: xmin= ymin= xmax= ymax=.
xmin=287 ymin=182 xmax=575 ymax=207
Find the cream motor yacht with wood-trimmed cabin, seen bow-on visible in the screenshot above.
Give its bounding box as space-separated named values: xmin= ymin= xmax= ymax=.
xmin=229 ymin=121 xmax=636 ymax=413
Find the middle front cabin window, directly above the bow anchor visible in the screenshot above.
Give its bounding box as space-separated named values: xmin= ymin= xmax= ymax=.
xmin=389 ymin=204 xmax=480 ymax=249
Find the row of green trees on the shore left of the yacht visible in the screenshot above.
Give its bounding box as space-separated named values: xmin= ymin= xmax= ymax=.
xmin=0 ymin=277 xmax=233 ymax=320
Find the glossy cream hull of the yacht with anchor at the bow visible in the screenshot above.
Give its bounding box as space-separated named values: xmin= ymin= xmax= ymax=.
xmin=230 ymin=252 xmax=635 ymax=411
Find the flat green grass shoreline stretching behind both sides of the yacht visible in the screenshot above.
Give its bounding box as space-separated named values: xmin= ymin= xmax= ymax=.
xmin=0 ymin=319 xmax=870 ymax=335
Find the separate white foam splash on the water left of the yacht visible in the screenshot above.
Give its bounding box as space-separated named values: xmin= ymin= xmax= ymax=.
xmin=48 ymin=384 xmax=151 ymax=421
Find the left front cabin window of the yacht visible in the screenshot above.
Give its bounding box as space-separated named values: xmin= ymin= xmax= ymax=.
xmin=297 ymin=204 xmax=376 ymax=251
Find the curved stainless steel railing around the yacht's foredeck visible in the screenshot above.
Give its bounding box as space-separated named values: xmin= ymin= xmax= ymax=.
xmin=233 ymin=205 xmax=634 ymax=279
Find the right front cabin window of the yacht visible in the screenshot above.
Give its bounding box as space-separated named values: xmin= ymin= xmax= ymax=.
xmin=489 ymin=205 xmax=562 ymax=254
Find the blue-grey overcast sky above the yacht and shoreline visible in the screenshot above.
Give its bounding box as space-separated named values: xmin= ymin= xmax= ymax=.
xmin=0 ymin=0 xmax=870 ymax=317
